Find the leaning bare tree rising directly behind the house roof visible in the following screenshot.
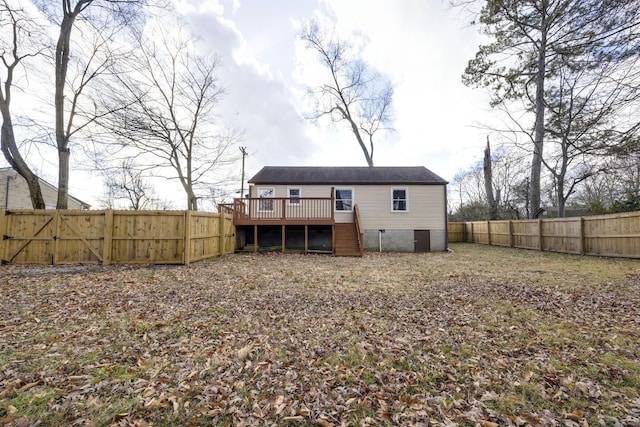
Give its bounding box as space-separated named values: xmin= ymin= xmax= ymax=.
xmin=300 ymin=21 xmax=393 ymax=166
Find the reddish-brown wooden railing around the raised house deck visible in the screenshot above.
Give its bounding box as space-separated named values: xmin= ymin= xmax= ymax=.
xmin=218 ymin=197 xmax=334 ymax=222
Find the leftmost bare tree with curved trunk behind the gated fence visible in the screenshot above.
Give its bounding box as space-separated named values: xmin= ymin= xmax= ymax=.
xmin=0 ymin=0 xmax=45 ymax=209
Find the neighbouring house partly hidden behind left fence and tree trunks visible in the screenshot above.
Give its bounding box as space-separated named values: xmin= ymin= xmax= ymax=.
xmin=0 ymin=168 xmax=91 ymax=209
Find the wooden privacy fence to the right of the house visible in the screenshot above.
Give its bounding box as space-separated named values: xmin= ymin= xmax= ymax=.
xmin=448 ymin=212 xmax=640 ymax=258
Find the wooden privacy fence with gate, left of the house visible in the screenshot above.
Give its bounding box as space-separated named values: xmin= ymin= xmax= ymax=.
xmin=0 ymin=209 xmax=235 ymax=265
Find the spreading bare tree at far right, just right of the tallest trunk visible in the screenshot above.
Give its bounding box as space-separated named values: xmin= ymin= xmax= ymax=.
xmin=543 ymin=57 xmax=640 ymax=217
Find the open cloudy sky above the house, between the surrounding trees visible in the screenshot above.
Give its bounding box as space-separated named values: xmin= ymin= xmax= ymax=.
xmin=166 ymin=0 xmax=496 ymax=194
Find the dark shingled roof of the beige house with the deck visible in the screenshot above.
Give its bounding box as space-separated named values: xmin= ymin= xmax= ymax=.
xmin=249 ymin=166 xmax=448 ymax=185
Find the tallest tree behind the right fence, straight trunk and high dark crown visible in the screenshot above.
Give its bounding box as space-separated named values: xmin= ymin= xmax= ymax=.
xmin=453 ymin=0 xmax=640 ymax=214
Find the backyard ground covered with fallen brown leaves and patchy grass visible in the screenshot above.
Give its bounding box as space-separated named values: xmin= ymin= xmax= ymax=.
xmin=0 ymin=245 xmax=640 ymax=427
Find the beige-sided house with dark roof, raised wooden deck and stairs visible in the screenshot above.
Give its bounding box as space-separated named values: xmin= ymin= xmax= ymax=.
xmin=221 ymin=166 xmax=447 ymax=256
